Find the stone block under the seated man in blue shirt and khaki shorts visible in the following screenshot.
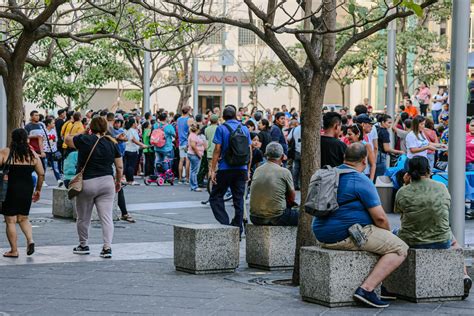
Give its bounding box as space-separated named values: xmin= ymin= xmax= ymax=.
xmin=300 ymin=247 xmax=380 ymax=307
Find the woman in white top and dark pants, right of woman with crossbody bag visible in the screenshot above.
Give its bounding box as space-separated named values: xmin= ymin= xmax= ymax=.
xmin=123 ymin=118 xmax=147 ymax=185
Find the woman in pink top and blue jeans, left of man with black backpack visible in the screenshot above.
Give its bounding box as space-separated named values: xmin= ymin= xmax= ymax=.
xmin=188 ymin=123 xmax=207 ymax=192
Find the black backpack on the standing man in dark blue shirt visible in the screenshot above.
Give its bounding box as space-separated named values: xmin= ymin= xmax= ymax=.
xmin=223 ymin=123 xmax=250 ymax=167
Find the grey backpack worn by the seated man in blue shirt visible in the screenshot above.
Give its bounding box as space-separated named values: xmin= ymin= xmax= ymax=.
xmin=304 ymin=166 xmax=357 ymax=217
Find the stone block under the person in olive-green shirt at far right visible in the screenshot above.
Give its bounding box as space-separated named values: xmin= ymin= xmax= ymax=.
xmin=383 ymin=249 xmax=464 ymax=302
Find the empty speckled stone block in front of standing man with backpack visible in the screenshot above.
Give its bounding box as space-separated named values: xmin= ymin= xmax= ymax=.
xmin=174 ymin=224 xmax=240 ymax=274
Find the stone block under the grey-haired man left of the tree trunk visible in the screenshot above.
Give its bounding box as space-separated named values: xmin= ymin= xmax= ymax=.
xmin=245 ymin=224 xmax=297 ymax=270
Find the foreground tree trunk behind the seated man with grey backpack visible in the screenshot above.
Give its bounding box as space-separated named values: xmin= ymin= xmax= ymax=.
xmin=293 ymin=73 xmax=329 ymax=285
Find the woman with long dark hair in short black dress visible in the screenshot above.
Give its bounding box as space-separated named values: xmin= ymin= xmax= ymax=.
xmin=0 ymin=128 xmax=44 ymax=258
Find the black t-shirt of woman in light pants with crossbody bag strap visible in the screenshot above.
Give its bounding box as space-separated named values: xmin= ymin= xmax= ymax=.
xmin=73 ymin=135 xmax=121 ymax=180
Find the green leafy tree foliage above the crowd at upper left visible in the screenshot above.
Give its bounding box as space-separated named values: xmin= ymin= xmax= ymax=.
xmin=25 ymin=40 xmax=130 ymax=110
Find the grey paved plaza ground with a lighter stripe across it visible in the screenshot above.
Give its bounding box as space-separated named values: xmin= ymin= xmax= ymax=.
xmin=0 ymin=177 xmax=474 ymax=315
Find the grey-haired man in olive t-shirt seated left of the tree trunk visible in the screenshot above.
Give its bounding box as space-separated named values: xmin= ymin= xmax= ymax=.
xmin=250 ymin=142 xmax=298 ymax=226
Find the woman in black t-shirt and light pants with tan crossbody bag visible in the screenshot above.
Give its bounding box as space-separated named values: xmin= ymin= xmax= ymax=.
xmin=65 ymin=117 xmax=123 ymax=258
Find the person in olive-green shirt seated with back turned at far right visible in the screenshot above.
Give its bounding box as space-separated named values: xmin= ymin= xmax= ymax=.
xmin=395 ymin=157 xmax=472 ymax=298
